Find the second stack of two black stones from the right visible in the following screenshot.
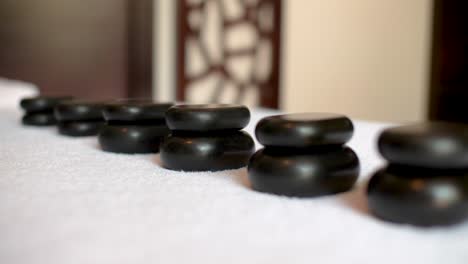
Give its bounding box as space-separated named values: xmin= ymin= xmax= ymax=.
xmin=248 ymin=113 xmax=359 ymax=197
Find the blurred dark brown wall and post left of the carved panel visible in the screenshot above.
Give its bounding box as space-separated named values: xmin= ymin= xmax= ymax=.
xmin=0 ymin=0 xmax=154 ymax=100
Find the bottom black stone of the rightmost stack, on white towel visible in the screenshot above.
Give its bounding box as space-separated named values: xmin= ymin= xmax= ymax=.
xmin=367 ymin=166 xmax=468 ymax=226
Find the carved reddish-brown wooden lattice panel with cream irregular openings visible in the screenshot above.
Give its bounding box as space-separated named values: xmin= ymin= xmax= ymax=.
xmin=177 ymin=0 xmax=281 ymax=108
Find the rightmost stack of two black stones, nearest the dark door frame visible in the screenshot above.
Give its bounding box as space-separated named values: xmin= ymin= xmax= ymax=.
xmin=367 ymin=122 xmax=468 ymax=226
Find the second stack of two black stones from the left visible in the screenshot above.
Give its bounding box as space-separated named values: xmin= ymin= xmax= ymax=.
xmin=54 ymin=101 xmax=104 ymax=137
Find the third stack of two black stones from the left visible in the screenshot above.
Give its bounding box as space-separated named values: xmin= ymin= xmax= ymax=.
xmin=98 ymin=100 xmax=173 ymax=154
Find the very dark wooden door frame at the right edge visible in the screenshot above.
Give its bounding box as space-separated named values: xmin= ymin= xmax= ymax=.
xmin=428 ymin=0 xmax=468 ymax=123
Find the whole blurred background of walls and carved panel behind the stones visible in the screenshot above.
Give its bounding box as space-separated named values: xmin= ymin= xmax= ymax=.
xmin=0 ymin=0 xmax=468 ymax=122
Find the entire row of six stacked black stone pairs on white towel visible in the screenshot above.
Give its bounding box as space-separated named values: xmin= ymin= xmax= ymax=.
xmin=21 ymin=97 xmax=468 ymax=226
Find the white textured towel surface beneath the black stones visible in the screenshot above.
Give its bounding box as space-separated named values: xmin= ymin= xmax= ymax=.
xmin=0 ymin=91 xmax=468 ymax=264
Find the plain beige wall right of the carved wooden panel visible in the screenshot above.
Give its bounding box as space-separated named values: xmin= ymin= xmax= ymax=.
xmin=282 ymin=0 xmax=432 ymax=122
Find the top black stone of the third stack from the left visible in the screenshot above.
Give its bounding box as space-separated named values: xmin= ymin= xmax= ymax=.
xmin=103 ymin=99 xmax=173 ymax=121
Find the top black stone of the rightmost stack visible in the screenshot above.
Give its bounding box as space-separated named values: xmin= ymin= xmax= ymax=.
xmin=378 ymin=122 xmax=468 ymax=169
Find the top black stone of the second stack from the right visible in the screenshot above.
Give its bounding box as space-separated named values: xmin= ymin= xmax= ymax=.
xmin=255 ymin=113 xmax=354 ymax=148
